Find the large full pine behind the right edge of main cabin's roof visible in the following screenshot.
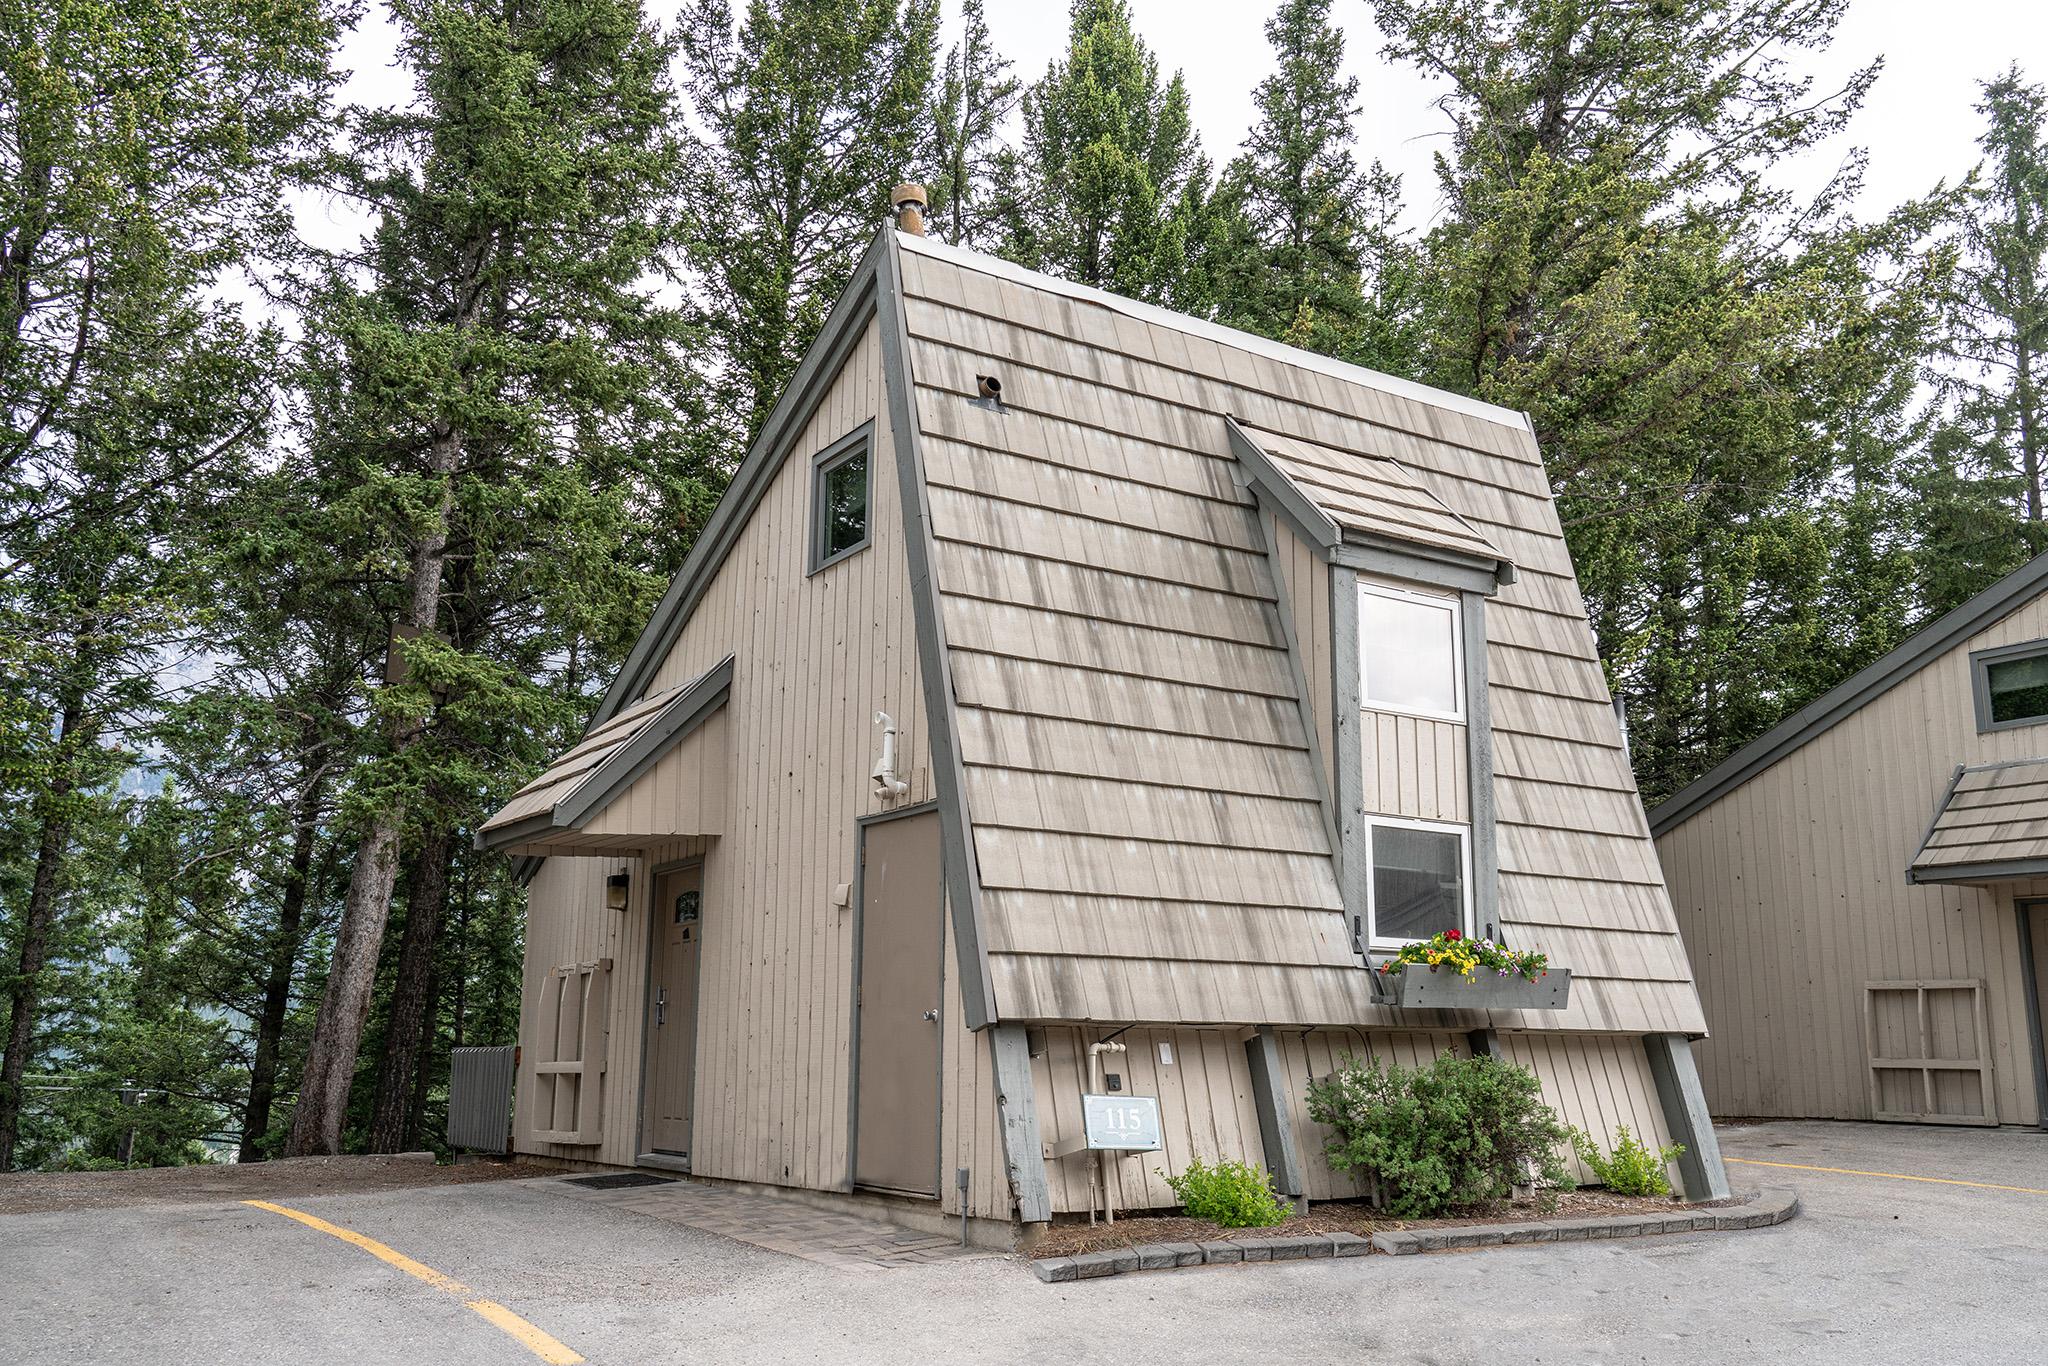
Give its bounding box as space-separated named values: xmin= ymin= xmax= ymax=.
xmin=1374 ymin=0 xmax=1954 ymax=799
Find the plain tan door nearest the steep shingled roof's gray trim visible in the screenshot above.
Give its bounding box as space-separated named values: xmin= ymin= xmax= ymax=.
xmin=854 ymin=813 xmax=944 ymax=1196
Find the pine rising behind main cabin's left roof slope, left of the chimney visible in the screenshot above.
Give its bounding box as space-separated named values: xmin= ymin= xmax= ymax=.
xmin=682 ymin=0 xmax=938 ymax=449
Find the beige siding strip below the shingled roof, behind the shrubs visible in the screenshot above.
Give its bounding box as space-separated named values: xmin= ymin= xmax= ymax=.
xmin=1032 ymin=1026 xmax=1669 ymax=1212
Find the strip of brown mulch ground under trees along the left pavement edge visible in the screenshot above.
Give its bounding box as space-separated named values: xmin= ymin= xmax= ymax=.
xmin=0 ymin=1157 xmax=559 ymax=1214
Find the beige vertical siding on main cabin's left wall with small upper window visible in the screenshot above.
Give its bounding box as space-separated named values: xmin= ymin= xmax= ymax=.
xmin=512 ymin=322 xmax=942 ymax=1190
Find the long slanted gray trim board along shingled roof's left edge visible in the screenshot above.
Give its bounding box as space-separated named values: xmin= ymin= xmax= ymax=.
xmin=874 ymin=227 xmax=999 ymax=1030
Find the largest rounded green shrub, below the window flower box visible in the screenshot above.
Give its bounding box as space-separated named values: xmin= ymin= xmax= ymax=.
xmin=1309 ymin=1053 xmax=1571 ymax=1219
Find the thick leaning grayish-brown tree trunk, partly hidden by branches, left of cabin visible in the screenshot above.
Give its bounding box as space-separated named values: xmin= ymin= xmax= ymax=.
xmin=285 ymin=421 xmax=473 ymax=1157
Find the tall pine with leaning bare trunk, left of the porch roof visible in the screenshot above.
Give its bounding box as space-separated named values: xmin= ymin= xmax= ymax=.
xmin=287 ymin=0 xmax=705 ymax=1155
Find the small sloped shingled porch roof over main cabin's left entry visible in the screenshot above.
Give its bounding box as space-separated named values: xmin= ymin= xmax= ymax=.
xmin=477 ymin=655 xmax=733 ymax=850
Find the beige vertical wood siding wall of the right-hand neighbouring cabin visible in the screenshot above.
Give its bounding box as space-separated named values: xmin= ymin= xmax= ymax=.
xmin=1657 ymin=598 xmax=2048 ymax=1122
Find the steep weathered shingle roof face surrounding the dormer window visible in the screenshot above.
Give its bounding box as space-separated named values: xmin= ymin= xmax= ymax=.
xmin=903 ymin=238 xmax=1704 ymax=1032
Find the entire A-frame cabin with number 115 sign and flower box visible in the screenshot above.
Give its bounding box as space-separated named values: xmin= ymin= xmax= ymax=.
xmin=479 ymin=190 xmax=1724 ymax=1237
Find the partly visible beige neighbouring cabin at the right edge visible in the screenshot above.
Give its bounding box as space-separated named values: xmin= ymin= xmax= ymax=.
xmin=1651 ymin=557 xmax=2048 ymax=1124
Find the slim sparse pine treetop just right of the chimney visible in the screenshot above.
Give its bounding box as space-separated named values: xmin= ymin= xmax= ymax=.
xmin=924 ymin=0 xmax=1024 ymax=250
